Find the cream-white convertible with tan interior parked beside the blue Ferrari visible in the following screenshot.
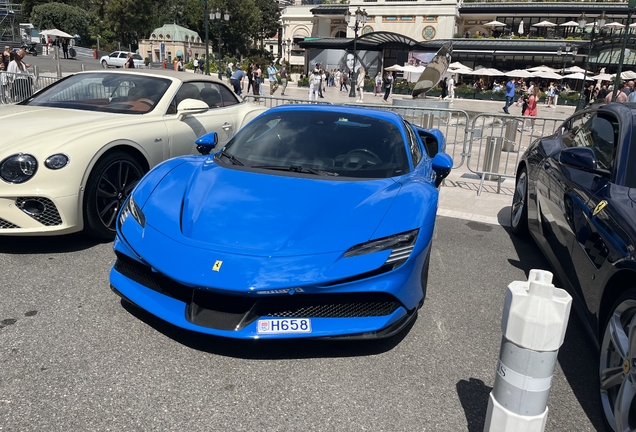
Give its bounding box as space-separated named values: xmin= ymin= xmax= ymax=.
xmin=0 ymin=69 xmax=264 ymax=239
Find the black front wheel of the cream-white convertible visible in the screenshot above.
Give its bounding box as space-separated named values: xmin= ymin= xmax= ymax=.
xmin=84 ymin=152 xmax=145 ymax=240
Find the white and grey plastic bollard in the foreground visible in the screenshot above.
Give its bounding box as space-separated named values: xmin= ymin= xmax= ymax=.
xmin=484 ymin=270 xmax=572 ymax=432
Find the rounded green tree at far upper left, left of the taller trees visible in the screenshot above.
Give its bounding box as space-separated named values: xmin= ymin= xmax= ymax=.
xmin=31 ymin=3 xmax=90 ymax=38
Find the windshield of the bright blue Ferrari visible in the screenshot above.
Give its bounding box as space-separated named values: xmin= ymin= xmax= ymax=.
xmin=219 ymin=109 xmax=409 ymax=178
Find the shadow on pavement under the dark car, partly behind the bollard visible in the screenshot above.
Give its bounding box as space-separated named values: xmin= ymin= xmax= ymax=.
xmin=504 ymin=228 xmax=605 ymax=431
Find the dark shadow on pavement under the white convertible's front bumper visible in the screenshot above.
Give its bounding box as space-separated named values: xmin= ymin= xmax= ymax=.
xmin=0 ymin=233 xmax=105 ymax=255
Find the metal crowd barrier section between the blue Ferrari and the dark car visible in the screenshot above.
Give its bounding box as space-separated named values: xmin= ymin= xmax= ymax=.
xmin=464 ymin=114 xmax=563 ymax=195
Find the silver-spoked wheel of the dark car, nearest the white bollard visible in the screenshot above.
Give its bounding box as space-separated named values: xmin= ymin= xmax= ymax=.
xmin=599 ymin=288 xmax=636 ymax=431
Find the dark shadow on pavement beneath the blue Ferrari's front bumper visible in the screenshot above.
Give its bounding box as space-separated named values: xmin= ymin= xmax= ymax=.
xmin=121 ymin=300 xmax=417 ymax=360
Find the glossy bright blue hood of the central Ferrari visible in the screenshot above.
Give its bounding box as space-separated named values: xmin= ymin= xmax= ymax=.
xmin=144 ymin=163 xmax=400 ymax=256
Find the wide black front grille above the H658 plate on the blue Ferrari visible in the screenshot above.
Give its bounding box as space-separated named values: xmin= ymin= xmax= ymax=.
xmin=115 ymin=253 xmax=401 ymax=330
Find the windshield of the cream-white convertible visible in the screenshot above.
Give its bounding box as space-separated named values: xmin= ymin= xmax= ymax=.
xmin=20 ymin=72 xmax=171 ymax=114
